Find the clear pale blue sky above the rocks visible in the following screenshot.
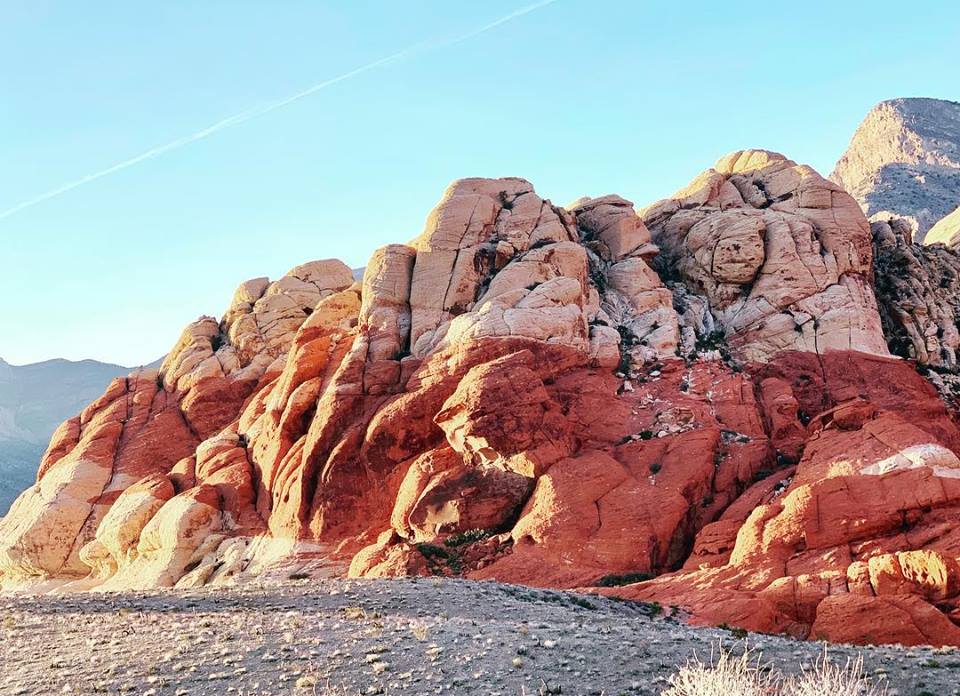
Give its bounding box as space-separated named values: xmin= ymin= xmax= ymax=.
xmin=0 ymin=0 xmax=960 ymax=365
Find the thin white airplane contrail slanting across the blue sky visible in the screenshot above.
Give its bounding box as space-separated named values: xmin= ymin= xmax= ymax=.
xmin=0 ymin=0 xmax=559 ymax=220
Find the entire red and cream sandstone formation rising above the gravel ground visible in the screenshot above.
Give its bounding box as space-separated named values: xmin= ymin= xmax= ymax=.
xmin=0 ymin=151 xmax=960 ymax=642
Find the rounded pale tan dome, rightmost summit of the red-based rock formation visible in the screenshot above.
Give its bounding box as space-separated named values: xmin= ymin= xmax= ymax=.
xmin=644 ymin=150 xmax=887 ymax=361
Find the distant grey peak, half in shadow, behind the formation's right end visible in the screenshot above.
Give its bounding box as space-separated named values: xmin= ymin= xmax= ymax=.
xmin=830 ymin=98 xmax=960 ymax=242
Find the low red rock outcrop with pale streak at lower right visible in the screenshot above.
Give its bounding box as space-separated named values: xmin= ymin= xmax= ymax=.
xmin=616 ymin=394 xmax=960 ymax=645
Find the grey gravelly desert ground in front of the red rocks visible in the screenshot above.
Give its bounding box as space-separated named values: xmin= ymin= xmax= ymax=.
xmin=0 ymin=578 xmax=960 ymax=696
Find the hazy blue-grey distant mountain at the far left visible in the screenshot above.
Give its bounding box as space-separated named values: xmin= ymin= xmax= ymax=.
xmin=0 ymin=359 xmax=137 ymax=515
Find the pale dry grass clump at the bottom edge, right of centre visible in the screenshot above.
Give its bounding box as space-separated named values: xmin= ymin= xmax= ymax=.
xmin=662 ymin=646 xmax=887 ymax=696
